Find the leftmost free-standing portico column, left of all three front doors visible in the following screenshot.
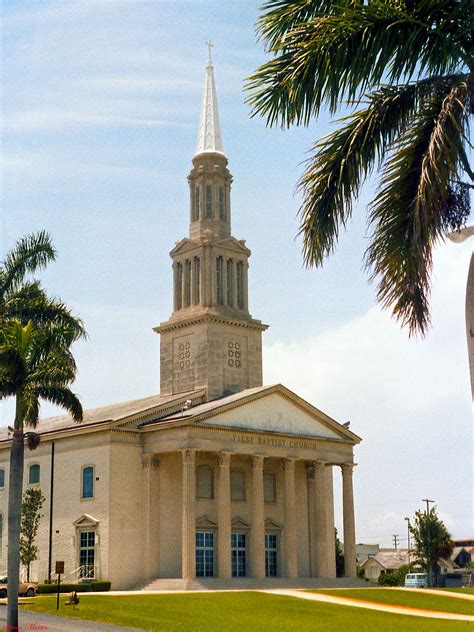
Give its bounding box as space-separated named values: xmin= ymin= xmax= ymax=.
xmin=181 ymin=450 xmax=196 ymax=579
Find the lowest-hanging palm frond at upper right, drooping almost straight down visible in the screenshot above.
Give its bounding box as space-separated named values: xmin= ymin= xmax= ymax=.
xmin=366 ymin=80 xmax=469 ymax=334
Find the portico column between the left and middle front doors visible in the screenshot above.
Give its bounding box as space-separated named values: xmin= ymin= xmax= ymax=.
xmin=217 ymin=452 xmax=232 ymax=579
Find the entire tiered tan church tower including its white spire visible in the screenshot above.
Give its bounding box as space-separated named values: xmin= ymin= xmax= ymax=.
xmin=155 ymin=48 xmax=267 ymax=400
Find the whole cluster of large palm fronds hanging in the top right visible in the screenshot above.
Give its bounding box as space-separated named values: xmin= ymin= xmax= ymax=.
xmin=247 ymin=0 xmax=474 ymax=335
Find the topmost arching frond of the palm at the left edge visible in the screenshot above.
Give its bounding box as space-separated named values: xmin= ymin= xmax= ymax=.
xmin=0 ymin=231 xmax=56 ymax=298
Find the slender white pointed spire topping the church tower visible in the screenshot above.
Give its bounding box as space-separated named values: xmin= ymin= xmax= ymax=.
xmin=196 ymin=41 xmax=224 ymax=156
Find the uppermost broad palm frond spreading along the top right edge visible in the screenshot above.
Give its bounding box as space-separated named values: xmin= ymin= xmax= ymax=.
xmin=246 ymin=0 xmax=468 ymax=126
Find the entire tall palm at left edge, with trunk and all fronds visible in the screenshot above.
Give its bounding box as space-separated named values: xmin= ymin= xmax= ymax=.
xmin=0 ymin=231 xmax=86 ymax=629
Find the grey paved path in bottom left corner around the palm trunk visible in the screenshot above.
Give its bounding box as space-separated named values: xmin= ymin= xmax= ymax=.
xmin=0 ymin=606 xmax=143 ymax=632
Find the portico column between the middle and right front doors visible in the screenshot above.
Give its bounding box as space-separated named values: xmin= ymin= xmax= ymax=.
xmin=250 ymin=455 xmax=265 ymax=578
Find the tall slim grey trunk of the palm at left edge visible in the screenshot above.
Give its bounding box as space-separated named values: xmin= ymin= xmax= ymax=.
xmin=7 ymin=396 xmax=25 ymax=630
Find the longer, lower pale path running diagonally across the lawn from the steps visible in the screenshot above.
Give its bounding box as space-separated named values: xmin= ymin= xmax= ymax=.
xmin=260 ymin=588 xmax=474 ymax=623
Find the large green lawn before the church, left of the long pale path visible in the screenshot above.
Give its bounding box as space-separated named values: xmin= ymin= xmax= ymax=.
xmin=25 ymin=592 xmax=472 ymax=632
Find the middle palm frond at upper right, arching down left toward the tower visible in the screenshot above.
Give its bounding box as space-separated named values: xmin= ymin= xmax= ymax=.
xmin=299 ymin=75 xmax=464 ymax=266
